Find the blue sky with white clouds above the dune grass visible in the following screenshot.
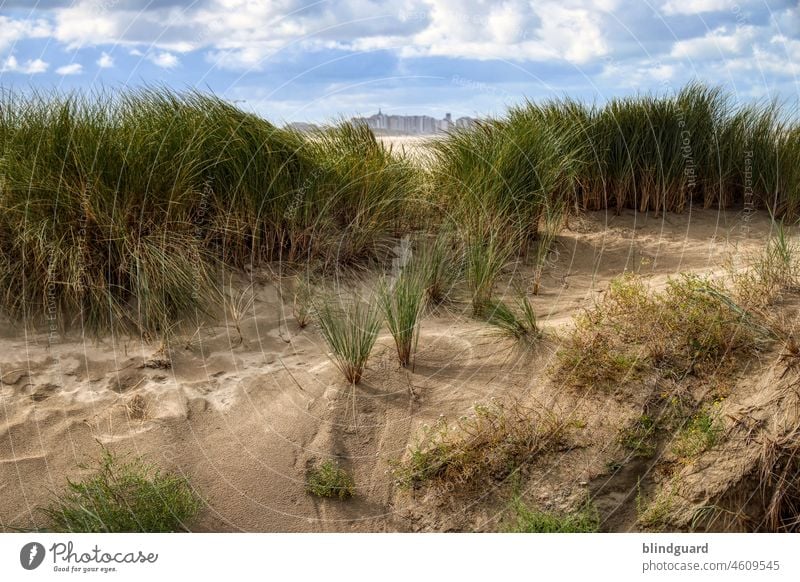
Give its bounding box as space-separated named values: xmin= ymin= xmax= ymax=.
xmin=0 ymin=0 xmax=800 ymax=122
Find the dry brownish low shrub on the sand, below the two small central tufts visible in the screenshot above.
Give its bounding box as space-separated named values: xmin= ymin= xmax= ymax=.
xmin=393 ymin=402 xmax=564 ymax=490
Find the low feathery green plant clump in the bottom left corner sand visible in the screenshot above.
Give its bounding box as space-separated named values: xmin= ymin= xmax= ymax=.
xmin=41 ymin=450 xmax=201 ymax=533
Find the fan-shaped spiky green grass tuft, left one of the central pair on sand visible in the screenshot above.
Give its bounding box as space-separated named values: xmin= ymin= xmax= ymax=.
xmin=314 ymin=298 xmax=381 ymax=384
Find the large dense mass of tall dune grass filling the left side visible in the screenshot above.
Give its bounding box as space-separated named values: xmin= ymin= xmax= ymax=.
xmin=0 ymin=88 xmax=416 ymax=333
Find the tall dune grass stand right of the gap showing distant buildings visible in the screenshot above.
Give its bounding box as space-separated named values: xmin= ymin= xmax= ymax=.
xmin=432 ymin=83 xmax=800 ymax=224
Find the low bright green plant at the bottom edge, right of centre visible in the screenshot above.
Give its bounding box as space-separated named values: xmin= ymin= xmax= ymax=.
xmin=503 ymin=495 xmax=600 ymax=533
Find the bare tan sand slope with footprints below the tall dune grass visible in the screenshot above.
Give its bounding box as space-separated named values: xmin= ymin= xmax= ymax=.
xmin=0 ymin=210 xmax=780 ymax=531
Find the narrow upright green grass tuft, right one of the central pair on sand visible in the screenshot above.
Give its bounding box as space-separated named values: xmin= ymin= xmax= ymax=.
xmin=378 ymin=270 xmax=425 ymax=368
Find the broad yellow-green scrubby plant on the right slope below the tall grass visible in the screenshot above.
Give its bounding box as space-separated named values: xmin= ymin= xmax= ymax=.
xmin=558 ymin=275 xmax=773 ymax=386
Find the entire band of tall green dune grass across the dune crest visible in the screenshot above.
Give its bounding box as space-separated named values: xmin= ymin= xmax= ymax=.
xmin=0 ymin=84 xmax=800 ymax=335
